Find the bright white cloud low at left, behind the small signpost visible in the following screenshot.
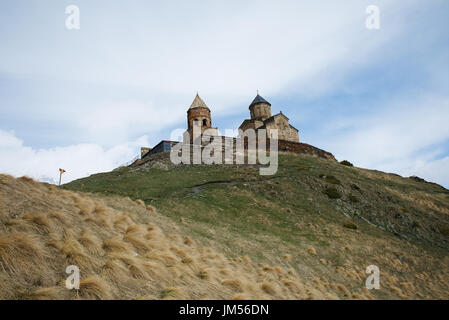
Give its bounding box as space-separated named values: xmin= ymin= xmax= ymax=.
xmin=0 ymin=130 xmax=148 ymax=183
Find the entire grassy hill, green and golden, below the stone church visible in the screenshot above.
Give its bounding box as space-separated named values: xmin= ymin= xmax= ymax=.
xmin=0 ymin=155 xmax=449 ymax=299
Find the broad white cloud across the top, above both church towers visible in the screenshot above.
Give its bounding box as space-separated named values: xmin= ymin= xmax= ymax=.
xmin=0 ymin=0 xmax=415 ymax=99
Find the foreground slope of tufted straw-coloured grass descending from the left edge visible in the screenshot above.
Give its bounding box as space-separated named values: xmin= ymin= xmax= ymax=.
xmin=0 ymin=175 xmax=322 ymax=299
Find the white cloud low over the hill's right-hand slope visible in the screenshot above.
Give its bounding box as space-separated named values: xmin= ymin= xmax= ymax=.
xmin=323 ymin=96 xmax=449 ymax=187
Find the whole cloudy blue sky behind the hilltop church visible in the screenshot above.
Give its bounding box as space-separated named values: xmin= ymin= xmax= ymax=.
xmin=0 ymin=0 xmax=449 ymax=188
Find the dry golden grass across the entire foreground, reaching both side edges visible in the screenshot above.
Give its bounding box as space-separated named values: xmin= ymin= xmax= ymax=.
xmin=0 ymin=175 xmax=449 ymax=300
